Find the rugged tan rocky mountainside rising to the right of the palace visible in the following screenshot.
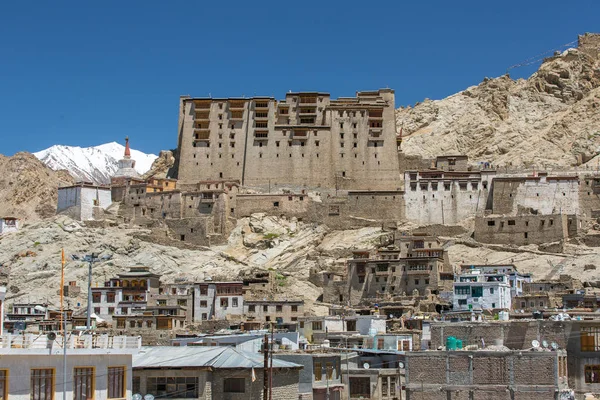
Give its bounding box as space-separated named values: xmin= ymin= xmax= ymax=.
xmin=396 ymin=35 xmax=600 ymax=168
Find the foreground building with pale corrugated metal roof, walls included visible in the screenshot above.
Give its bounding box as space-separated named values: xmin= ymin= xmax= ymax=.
xmin=133 ymin=346 xmax=302 ymax=400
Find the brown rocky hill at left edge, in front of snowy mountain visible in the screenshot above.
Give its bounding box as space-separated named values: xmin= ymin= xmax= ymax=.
xmin=0 ymin=153 xmax=74 ymax=222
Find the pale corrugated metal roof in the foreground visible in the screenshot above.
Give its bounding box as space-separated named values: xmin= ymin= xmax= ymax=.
xmin=133 ymin=346 xmax=302 ymax=368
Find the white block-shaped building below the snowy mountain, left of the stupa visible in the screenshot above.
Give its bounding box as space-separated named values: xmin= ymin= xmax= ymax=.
xmin=56 ymin=182 xmax=112 ymax=221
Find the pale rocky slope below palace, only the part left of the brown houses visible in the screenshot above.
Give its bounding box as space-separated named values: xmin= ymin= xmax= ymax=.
xmin=0 ymin=214 xmax=382 ymax=313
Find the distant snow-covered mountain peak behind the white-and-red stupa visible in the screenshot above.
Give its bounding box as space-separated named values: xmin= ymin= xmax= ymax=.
xmin=33 ymin=142 xmax=157 ymax=184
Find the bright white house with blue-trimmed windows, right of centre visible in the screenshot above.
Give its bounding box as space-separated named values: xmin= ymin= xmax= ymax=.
xmin=452 ymin=269 xmax=512 ymax=310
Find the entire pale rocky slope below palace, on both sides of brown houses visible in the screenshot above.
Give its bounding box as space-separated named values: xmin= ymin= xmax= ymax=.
xmin=0 ymin=214 xmax=600 ymax=315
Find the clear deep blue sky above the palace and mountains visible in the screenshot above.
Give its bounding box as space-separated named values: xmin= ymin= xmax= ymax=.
xmin=0 ymin=0 xmax=600 ymax=155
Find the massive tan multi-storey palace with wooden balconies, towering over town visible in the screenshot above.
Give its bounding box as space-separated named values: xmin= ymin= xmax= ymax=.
xmin=178 ymin=89 xmax=401 ymax=191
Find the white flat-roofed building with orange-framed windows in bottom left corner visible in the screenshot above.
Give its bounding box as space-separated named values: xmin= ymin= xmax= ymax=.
xmin=0 ymin=335 xmax=141 ymax=400
